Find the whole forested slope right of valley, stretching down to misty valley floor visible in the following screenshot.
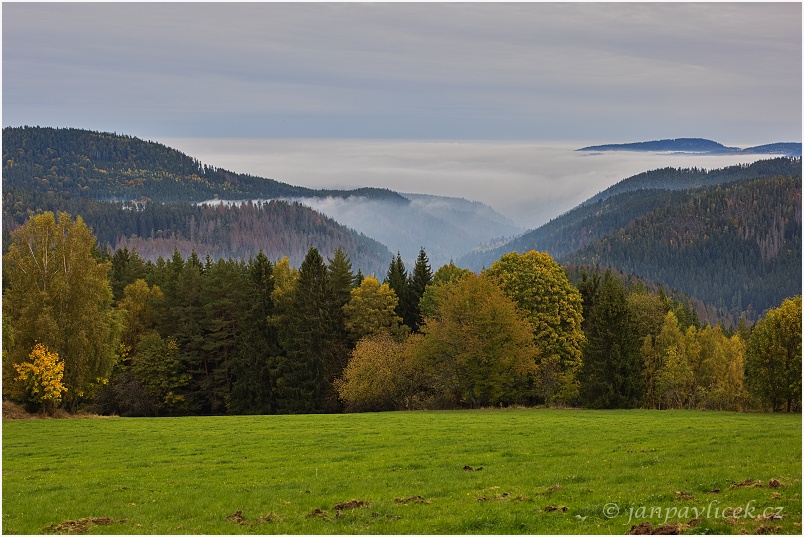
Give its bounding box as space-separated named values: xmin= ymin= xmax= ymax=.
xmin=458 ymin=163 xmax=801 ymax=319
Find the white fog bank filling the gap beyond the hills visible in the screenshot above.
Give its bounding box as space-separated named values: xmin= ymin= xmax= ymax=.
xmin=159 ymin=138 xmax=784 ymax=228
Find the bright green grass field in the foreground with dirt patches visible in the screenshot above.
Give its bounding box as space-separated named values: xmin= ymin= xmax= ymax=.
xmin=2 ymin=409 xmax=802 ymax=534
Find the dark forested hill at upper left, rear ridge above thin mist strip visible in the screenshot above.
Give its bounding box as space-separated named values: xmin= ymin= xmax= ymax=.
xmin=3 ymin=127 xmax=408 ymax=203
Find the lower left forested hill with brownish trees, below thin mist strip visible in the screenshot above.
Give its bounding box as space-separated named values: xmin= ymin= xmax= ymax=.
xmin=3 ymin=186 xmax=390 ymax=273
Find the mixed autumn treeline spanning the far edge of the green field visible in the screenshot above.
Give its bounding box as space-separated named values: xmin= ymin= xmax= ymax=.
xmin=3 ymin=213 xmax=801 ymax=416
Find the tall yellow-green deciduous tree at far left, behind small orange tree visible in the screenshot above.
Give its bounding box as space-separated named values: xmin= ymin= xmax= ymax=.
xmin=3 ymin=213 xmax=119 ymax=407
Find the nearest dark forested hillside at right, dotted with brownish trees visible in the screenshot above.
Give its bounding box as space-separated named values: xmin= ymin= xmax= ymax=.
xmin=563 ymin=175 xmax=802 ymax=319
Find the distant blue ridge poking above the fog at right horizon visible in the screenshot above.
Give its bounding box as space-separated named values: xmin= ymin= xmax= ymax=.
xmin=577 ymin=138 xmax=801 ymax=157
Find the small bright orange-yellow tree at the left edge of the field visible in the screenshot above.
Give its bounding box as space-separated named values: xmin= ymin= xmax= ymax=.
xmin=14 ymin=343 xmax=67 ymax=410
